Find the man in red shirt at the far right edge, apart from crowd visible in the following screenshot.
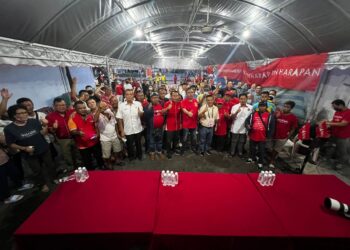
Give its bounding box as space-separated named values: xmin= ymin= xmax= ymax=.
xmin=326 ymin=99 xmax=350 ymax=169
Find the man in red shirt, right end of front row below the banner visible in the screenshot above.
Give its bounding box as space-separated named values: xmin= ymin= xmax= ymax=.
xmin=268 ymin=101 xmax=298 ymax=168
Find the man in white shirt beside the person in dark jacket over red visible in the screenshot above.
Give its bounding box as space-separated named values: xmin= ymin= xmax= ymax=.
xmin=230 ymin=94 xmax=253 ymax=157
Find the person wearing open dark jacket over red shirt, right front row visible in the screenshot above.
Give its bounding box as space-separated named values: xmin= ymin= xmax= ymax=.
xmin=246 ymin=102 xmax=275 ymax=169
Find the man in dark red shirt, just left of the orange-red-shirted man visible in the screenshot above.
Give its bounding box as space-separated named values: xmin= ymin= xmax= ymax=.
xmin=46 ymin=97 xmax=78 ymax=171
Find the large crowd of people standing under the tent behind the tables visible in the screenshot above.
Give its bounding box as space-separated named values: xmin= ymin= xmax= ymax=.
xmin=0 ymin=76 xmax=350 ymax=203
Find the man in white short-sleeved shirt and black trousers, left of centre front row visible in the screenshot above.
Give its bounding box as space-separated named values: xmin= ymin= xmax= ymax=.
xmin=116 ymin=89 xmax=143 ymax=161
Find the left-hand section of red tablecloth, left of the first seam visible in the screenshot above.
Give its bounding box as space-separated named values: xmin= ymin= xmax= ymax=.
xmin=15 ymin=171 xmax=160 ymax=249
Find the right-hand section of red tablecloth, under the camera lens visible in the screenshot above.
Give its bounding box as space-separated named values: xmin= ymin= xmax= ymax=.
xmin=249 ymin=174 xmax=350 ymax=237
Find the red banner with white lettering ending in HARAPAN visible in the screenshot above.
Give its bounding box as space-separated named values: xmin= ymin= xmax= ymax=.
xmin=218 ymin=53 xmax=328 ymax=91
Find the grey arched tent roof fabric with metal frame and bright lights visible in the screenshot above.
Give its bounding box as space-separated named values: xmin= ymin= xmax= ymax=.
xmin=0 ymin=0 xmax=350 ymax=65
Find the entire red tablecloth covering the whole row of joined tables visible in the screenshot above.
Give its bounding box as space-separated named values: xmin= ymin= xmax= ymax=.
xmin=15 ymin=171 xmax=350 ymax=250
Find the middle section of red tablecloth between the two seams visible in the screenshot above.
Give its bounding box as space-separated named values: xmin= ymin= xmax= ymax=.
xmin=154 ymin=173 xmax=286 ymax=249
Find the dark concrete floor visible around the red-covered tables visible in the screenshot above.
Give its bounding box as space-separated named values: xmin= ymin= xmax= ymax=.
xmin=0 ymin=151 xmax=350 ymax=250
